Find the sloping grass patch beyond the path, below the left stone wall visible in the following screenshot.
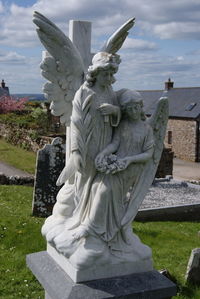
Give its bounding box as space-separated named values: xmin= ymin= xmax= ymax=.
xmin=0 ymin=138 xmax=36 ymax=174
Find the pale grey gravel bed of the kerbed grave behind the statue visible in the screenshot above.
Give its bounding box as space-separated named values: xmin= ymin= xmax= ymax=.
xmin=140 ymin=180 xmax=200 ymax=209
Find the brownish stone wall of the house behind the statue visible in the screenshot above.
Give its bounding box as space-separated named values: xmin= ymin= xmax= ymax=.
xmin=165 ymin=119 xmax=197 ymax=162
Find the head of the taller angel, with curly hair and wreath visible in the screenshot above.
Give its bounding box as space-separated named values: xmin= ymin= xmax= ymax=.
xmin=86 ymin=52 xmax=120 ymax=86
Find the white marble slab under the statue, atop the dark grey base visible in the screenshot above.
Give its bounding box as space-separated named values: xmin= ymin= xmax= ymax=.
xmin=47 ymin=244 xmax=153 ymax=282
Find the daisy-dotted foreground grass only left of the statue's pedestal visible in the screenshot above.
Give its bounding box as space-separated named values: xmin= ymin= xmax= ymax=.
xmin=0 ymin=186 xmax=45 ymax=299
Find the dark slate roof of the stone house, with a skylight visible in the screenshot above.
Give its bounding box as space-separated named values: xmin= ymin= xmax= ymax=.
xmin=139 ymin=87 xmax=200 ymax=119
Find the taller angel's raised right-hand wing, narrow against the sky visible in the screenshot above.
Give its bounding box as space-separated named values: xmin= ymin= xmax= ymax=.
xmin=101 ymin=18 xmax=135 ymax=54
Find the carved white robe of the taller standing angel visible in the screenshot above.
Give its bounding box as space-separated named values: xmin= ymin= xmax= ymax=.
xmin=66 ymin=82 xmax=120 ymax=229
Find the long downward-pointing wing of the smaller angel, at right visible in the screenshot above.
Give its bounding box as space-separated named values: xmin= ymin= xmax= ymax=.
xmin=122 ymin=97 xmax=169 ymax=226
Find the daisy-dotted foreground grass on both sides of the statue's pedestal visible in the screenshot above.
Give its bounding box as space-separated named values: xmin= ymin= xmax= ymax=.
xmin=0 ymin=186 xmax=200 ymax=299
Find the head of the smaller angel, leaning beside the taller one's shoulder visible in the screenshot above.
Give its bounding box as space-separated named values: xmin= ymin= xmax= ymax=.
xmin=119 ymin=89 xmax=146 ymax=120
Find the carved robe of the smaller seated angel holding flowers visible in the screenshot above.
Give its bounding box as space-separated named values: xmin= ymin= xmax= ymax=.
xmin=79 ymin=120 xmax=154 ymax=254
